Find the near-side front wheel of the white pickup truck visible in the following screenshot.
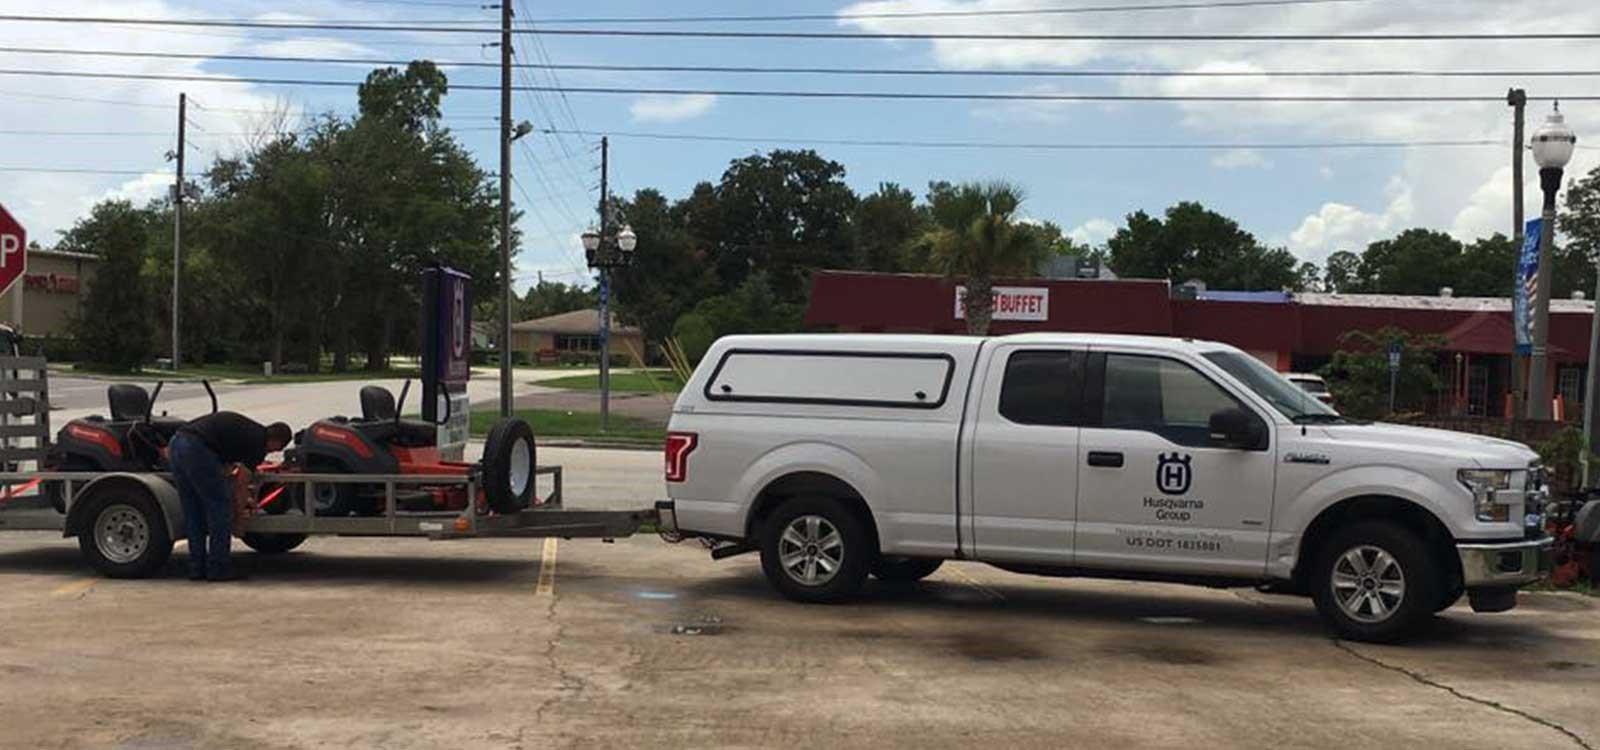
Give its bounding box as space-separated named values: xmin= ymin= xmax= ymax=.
xmin=1312 ymin=521 xmax=1445 ymax=643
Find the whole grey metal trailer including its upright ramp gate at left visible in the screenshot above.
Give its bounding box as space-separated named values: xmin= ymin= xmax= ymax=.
xmin=0 ymin=355 xmax=658 ymax=577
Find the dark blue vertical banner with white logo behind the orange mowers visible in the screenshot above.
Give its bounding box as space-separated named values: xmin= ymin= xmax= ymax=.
xmin=422 ymin=267 xmax=472 ymax=461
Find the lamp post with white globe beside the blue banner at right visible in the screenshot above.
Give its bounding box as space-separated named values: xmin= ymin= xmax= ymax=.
xmin=1528 ymin=102 xmax=1578 ymax=419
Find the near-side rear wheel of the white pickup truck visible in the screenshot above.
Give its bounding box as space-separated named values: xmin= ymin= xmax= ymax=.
xmin=762 ymin=497 xmax=877 ymax=603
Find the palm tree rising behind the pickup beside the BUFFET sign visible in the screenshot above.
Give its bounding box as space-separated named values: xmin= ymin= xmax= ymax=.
xmin=923 ymin=182 xmax=1046 ymax=336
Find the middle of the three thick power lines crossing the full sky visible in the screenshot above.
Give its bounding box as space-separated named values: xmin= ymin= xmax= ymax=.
xmin=0 ymin=46 xmax=1600 ymax=79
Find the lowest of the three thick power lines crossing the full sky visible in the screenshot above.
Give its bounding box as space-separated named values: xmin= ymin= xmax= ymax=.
xmin=0 ymin=69 xmax=1600 ymax=102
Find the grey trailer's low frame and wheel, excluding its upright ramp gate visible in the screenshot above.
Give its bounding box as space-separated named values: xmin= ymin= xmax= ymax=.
xmin=0 ymin=465 xmax=658 ymax=577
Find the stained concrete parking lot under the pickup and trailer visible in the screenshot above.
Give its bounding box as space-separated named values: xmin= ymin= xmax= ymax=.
xmin=0 ymin=449 xmax=1600 ymax=750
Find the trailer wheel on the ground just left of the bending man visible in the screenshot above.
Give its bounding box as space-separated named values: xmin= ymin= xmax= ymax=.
xmin=78 ymin=486 xmax=173 ymax=579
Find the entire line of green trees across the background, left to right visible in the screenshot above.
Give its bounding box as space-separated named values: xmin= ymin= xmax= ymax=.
xmin=46 ymin=61 xmax=1600 ymax=371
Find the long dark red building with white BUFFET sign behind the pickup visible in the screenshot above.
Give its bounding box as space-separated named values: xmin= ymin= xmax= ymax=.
xmin=805 ymin=270 xmax=1592 ymax=417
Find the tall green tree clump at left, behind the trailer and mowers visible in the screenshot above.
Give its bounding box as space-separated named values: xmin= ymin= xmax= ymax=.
xmin=67 ymin=62 xmax=499 ymax=371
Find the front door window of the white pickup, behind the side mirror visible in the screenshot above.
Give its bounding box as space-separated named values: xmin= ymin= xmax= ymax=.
xmin=1101 ymin=353 xmax=1250 ymax=448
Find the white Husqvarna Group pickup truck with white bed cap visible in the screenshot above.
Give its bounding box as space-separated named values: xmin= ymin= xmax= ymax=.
xmin=659 ymin=334 xmax=1549 ymax=641
